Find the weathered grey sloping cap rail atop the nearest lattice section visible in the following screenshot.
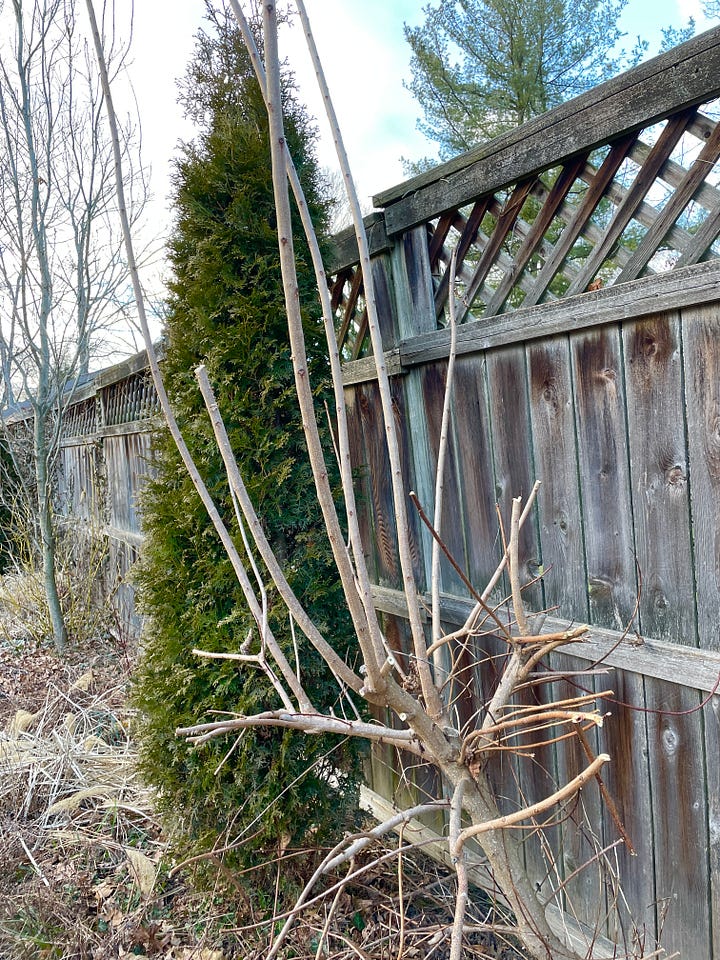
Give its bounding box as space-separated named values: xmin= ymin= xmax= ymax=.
xmin=373 ymin=27 xmax=720 ymax=235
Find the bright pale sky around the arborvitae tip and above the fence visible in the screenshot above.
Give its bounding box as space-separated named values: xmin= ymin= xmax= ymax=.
xmin=120 ymin=0 xmax=708 ymax=266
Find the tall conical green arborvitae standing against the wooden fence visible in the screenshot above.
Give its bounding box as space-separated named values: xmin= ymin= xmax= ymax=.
xmin=135 ymin=7 xmax=357 ymax=892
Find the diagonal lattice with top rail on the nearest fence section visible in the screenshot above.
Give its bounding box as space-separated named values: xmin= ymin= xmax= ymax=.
xmin=331 ymin=30 xmax=720 ymax=359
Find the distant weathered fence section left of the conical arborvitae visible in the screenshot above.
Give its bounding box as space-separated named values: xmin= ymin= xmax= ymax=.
xmin=56 ymin=351 xmax=160 ymax=631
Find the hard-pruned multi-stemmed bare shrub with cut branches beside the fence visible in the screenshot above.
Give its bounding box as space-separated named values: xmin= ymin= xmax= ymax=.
xmin=86 ymin=0 xmax=644 ymax=960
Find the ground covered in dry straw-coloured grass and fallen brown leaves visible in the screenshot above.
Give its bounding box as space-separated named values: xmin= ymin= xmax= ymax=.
xmin=0 ymin=637 xmax=522 ymax=960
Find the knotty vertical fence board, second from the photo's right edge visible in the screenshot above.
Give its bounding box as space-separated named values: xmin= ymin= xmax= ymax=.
xmin=624 ymin=314 xmax=710 ymax=956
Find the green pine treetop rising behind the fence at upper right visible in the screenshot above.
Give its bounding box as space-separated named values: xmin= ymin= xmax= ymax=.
xmin=405 ymin=0 xmax=692 ymax=160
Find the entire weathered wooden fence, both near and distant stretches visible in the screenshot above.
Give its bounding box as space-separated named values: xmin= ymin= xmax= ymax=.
xmin=50 ymin=30 xmax=720 ymax=960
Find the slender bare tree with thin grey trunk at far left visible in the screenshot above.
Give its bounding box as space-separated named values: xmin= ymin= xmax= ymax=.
xmin=0 ymin=0 xmax=145 ymax=650
